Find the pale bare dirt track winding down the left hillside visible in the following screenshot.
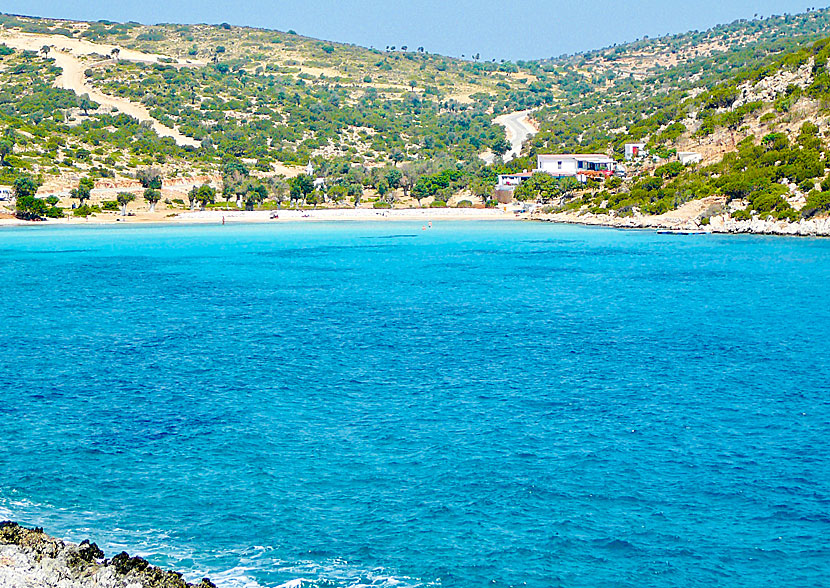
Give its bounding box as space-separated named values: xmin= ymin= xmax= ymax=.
xmin=0 ymin=32 xmax=202 ymax=147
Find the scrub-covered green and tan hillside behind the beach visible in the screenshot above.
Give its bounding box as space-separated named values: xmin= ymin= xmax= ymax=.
xmin=0 ymin=10 xmax=830 ymax=226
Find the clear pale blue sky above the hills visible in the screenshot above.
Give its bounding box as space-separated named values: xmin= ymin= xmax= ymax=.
xmin=0 ymin=0 xmax=825 ymax=60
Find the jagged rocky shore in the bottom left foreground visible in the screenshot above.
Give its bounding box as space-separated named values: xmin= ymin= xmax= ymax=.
xmin=0 ymin=521 xmax=216 ymax=588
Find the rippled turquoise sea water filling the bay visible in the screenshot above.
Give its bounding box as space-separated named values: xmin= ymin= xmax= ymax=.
xmin=0 ymin=223 xmax=830 ymax=588
